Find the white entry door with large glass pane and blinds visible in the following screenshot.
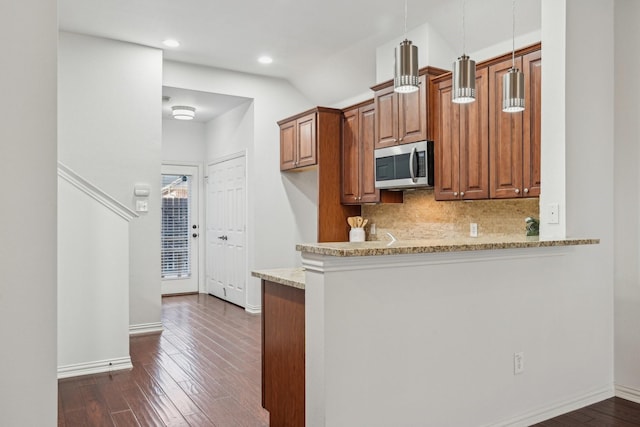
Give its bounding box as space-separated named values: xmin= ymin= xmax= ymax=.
xmin=161 ymin=165 xmax=200 ymax=295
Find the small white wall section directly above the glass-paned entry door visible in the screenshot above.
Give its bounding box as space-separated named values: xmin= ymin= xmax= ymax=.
xmin=162 ymin=119 xmax=206 ymax=164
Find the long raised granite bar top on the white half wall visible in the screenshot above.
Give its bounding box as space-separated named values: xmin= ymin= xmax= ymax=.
xmin=296 ymin=234 xmax=600 ymax=257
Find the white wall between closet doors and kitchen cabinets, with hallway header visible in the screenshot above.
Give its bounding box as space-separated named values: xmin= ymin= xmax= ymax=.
xmin=163 ymin=61 xmax=317 ymax=306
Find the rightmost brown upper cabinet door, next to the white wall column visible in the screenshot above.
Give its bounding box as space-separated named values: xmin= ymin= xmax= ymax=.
xmin=522 ymin=51 xmax=542 ymax=197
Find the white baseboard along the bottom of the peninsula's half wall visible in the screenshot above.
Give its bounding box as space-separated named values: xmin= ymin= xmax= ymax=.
xmin=487 ymin=386 xmax=614 ymax=427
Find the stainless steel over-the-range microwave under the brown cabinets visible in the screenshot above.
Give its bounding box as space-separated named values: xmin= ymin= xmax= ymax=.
xmin=375 ymin=141 xmax=433 ymax=189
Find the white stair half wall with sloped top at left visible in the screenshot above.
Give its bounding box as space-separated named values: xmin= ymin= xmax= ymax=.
xmin=58 ymin=174 xmax=134 ymax=378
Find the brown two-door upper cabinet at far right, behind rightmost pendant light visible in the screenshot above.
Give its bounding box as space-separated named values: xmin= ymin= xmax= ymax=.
xmin=489 ymin=50 xmax=542 ymax=199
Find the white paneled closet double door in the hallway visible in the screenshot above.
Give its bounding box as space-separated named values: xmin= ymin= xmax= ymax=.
xmin=206 ymin=156 xmax=247 ymax=307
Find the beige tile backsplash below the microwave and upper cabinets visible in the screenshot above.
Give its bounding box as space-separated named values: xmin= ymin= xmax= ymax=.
xmin=362 ymin=190 xmax=539 ymax=240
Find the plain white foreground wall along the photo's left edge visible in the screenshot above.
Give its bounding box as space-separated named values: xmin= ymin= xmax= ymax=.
xmin=0 ymin=0 xmax=58 ymax=426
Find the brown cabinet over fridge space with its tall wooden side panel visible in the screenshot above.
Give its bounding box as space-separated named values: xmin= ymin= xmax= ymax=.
xmin=278 ymin=107 xmax=360 ymax=243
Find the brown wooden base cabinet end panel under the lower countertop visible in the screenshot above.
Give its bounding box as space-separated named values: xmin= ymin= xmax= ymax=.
xmin=262 ymin=280 xmax=305 ymax=427
